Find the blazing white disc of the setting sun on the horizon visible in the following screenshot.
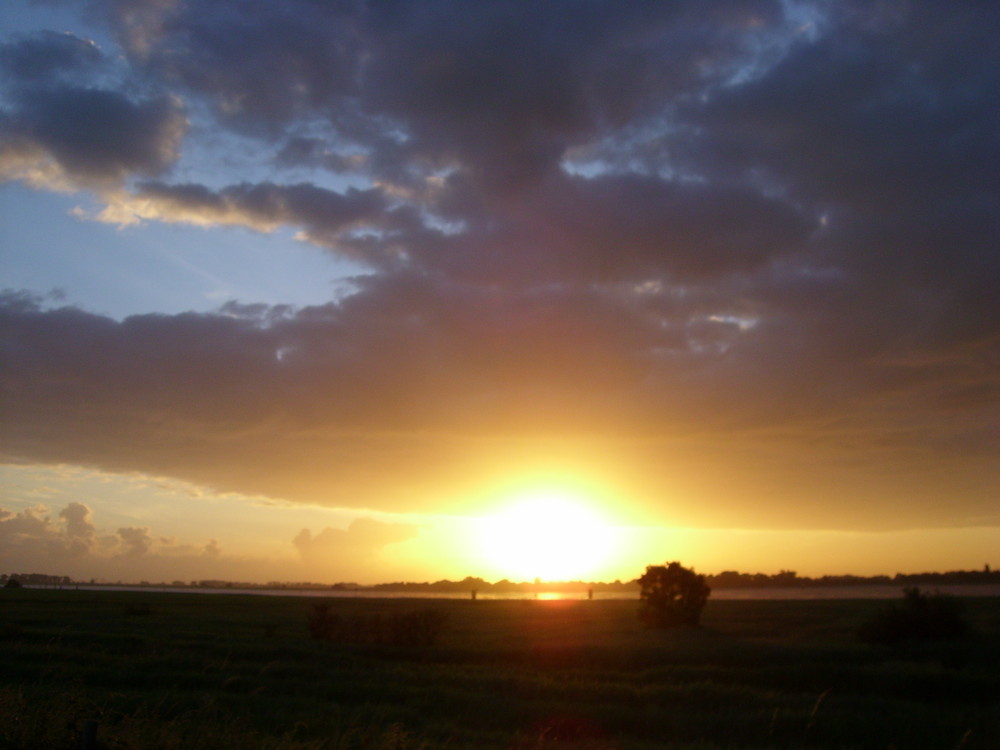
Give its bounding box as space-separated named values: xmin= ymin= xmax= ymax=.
xmin=479 ymin=491 xmax=615 ymax=581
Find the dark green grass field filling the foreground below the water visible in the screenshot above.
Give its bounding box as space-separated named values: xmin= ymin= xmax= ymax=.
xmin=0 ymin=589 xmax=1000 ymax=750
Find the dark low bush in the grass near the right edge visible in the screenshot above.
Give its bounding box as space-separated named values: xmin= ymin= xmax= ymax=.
xmin=858 ymin=586 xmax=969 ymax=646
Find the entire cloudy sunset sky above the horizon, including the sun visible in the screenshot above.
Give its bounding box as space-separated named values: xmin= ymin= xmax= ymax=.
xmin=0 ymin=0 xmax=1000 ymax=583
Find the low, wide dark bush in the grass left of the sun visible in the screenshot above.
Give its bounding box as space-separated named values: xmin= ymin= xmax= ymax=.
xmin=306 ymin=602 xmax=448 ymax=648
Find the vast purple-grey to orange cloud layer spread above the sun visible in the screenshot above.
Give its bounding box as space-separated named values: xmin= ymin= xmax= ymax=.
xmin=0 ymin=0 xmax=1000 ymax=536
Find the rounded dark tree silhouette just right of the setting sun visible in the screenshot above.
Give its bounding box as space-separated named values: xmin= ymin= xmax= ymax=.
xmin=639 ymin=562 xmax=712 ymax=628
